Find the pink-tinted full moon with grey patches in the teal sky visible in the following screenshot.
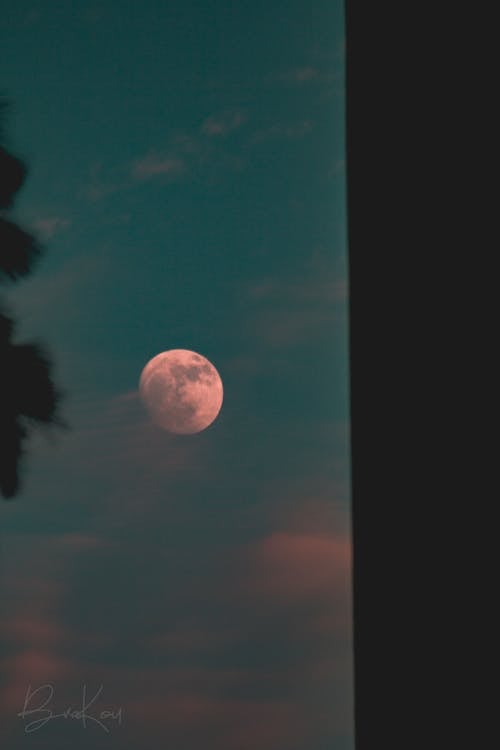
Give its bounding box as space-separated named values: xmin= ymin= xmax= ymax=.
xmin=139 ymin=349 xmax=223 ymax=435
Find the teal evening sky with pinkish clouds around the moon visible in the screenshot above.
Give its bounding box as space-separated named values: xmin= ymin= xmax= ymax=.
xmin=0 ymin=0 xmax=354 ymax=750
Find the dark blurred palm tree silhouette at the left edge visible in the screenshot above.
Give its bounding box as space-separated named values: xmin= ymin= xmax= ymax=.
xmin=0 ymin=101 xmax=66 ymax=499
